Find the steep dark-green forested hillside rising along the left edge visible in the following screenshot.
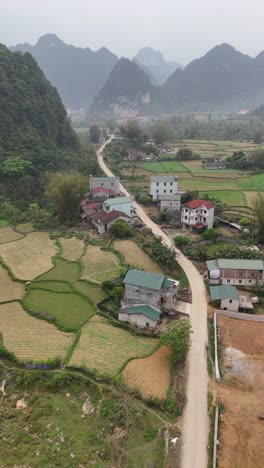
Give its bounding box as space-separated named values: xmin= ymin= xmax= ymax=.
xmin=0 ymin=45 xmax=96 ymax=203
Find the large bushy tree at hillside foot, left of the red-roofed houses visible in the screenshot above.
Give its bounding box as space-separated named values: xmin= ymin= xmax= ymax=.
xmin=46 ymin=172 xmax=88 ymax=223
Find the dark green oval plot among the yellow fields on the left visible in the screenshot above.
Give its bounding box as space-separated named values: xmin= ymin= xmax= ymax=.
xmin=23 ymin=289 xmax=95 ymax=329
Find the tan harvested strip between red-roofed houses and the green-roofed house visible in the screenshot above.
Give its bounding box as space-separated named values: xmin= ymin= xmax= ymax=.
xmin=114 ymin=240 xmax=162 ymax=273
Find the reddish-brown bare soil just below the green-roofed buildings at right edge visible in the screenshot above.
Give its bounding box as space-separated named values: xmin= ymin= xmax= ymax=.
xmin=218 ymin=316 xmax=264 ymax=356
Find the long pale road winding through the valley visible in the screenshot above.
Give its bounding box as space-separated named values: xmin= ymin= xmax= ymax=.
xmin=97 ymin=140 xmax=209 ymax=468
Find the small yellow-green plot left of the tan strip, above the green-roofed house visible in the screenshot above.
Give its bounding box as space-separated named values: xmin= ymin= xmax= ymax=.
xmin=82 ymin=245 xmax=120 ymax=283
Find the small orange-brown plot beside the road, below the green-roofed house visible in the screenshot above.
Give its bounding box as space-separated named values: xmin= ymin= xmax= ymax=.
xmin=123 ymin=346 xmax=170 ymax=400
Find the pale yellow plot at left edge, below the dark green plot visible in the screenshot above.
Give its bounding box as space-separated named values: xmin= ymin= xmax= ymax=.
xmin=0 ymin=302 xmax=75 ymax=362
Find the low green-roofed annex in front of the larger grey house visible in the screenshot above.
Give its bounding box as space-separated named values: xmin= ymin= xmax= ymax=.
xmin=118 ymin=304 xmax=161 ymax=330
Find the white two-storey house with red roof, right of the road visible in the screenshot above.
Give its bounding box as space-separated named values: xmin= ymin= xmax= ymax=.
xmin=181 ymin=200 xmax=214 ymax=231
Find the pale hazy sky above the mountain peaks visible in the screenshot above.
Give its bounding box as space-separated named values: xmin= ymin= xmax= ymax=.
xmin=0 ymin=0 xmax=264 ymax=64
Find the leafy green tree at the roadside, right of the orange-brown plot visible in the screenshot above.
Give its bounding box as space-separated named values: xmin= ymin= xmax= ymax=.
xmin=160 ymin=319 xmax=191 ymax=364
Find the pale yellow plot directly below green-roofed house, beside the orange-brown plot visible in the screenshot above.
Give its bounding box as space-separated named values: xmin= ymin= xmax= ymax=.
xmin=69 ymin=316 xmax=157 ymax=377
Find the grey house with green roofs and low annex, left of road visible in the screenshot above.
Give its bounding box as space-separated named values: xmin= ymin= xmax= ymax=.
xmin=119 ymin=270 xmax=179 ymax=328
